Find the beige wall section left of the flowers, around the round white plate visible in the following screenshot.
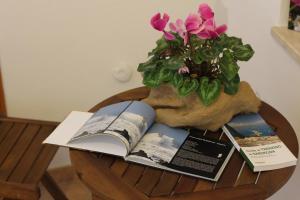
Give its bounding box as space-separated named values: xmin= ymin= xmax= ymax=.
xmin=0 ymin=0 xmax=216 ymax=120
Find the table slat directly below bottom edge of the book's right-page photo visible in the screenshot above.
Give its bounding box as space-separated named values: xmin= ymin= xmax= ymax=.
xmin=136 ymin=167 xmax=162 ymax=196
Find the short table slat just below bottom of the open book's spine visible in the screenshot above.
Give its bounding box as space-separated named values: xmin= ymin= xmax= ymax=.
xmin=123 ymin=164 xmax=145 ymax=186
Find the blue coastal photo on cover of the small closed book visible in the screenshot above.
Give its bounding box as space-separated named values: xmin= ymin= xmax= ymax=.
xmin=225 ymin=113 xmax=280 ymax=147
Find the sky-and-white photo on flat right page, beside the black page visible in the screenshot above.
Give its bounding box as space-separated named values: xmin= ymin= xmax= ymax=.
xmin=130 ymin=123 xmax=189 ymax=165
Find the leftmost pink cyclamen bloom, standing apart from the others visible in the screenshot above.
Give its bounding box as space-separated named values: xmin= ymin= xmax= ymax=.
xmin=150 ymin=13 xmax=175 ymax=40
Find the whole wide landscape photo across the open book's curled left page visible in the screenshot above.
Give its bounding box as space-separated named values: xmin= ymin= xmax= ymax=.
xmin=70 ymin=101 xmax=155 ymax=149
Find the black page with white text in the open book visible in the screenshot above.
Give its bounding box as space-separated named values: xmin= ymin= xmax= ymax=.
xmin=168 ymin=129 xmax=234 ymax=181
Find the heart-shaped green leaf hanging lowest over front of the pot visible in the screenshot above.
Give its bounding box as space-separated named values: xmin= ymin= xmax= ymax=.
xmin=198 ymin=77 xmax=221 ymax=106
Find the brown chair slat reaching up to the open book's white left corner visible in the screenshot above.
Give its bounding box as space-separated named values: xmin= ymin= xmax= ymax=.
xmin=8 ymin=126 xmax=54 ymax=183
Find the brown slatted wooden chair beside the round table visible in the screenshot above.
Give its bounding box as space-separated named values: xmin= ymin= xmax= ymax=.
xmin=0 ymin=70 xmax=67 ymax=200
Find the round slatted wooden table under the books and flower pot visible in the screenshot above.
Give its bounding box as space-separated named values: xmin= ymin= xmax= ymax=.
xmin=70 ymin=87 xmax=298 ymax=200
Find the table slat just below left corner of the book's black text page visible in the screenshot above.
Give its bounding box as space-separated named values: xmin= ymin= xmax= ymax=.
xmin=151 ymin=171 xmax=180 ymax=197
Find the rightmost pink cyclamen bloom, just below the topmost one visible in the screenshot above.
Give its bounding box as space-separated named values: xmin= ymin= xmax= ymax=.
xmin=197 ymin=18 xmax=227 ymax=39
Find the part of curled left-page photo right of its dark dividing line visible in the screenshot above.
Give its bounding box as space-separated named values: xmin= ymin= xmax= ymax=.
xmin=105 ymin=101 xmax=155 ymax=150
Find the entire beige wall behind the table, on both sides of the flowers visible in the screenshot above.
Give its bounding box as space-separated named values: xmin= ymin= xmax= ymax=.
xmin=0 ymin=0 xmax=300 ymax=199
